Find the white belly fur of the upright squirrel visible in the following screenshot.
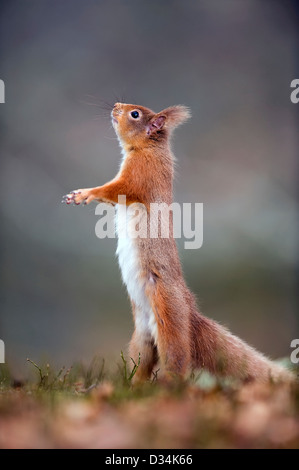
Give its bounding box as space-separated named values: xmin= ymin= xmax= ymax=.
xmin=116 ymin=205 xmax=158 ymax=343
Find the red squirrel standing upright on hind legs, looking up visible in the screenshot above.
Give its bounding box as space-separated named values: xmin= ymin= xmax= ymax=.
xmin=64 ymin=103 xmax=293 ymax=382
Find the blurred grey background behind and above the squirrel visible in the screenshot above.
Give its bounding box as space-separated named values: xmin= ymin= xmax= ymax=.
xmin=0 ymin=0 xmax=299 ymax=375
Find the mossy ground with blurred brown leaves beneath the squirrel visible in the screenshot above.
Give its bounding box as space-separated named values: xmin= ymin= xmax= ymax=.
xmin=0 ymin=358 xmax=299 ymax=449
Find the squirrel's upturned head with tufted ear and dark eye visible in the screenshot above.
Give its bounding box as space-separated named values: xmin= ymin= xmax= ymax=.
xmin=111 ymin=103 xmax=191 ymax=148
